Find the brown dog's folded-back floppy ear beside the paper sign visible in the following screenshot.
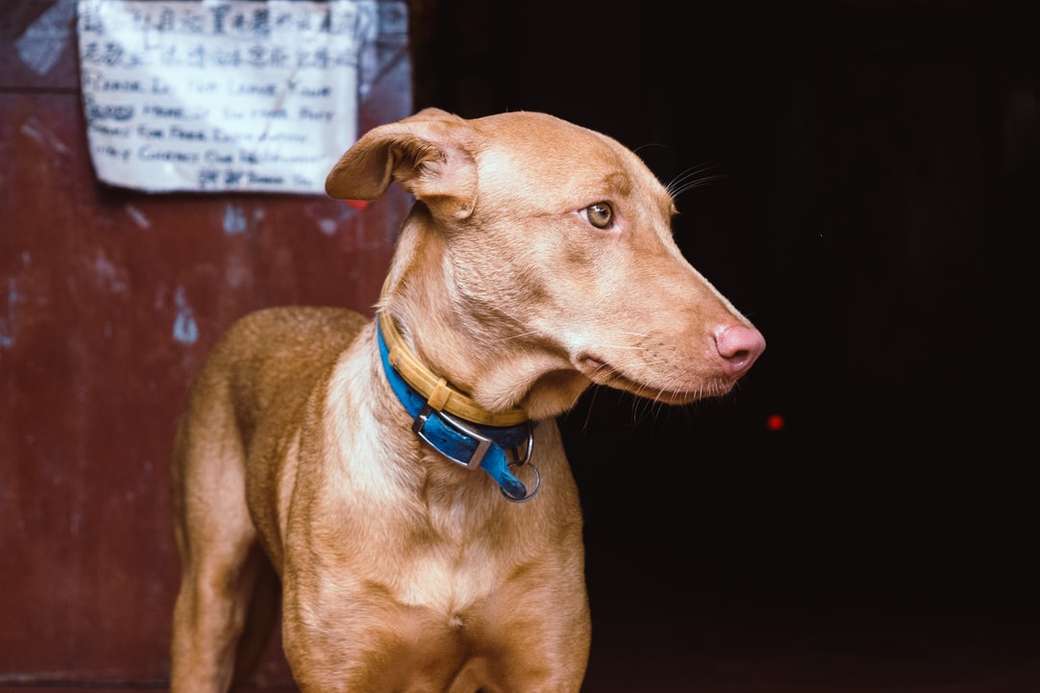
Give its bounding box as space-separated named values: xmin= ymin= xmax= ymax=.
xmin=326 ymin=108 xmax=476 ymax=220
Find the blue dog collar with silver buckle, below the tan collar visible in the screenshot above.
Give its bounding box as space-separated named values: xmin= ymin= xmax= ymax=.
xmin=375 ymin=319 xmax=542 ymax=502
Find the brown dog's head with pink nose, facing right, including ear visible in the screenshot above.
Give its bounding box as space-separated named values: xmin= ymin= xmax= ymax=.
xmin=326 ymin=109 xmax=765 ymax=417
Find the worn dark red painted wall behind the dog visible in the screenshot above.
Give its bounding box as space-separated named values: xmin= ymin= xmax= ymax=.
xmin=0 ymin=0 xmax=411 ymax=686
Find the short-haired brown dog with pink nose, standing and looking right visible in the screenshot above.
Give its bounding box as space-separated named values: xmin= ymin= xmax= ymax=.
xmin=173 ymin=109 xmax=764 ymax=693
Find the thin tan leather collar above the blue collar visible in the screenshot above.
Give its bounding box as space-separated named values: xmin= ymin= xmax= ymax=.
xmin=379 ymin=311 xmax=527 ymax=426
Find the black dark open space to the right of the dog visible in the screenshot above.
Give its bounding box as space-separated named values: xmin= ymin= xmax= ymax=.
xmin=416 ymin=1 xmax=1040 ymax=691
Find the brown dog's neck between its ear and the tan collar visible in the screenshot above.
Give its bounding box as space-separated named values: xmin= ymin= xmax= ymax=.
xmin=382 ymin=205 xmax=589 ymax=419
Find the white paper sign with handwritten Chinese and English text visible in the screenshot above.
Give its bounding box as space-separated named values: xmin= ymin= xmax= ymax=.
xmin=78 ymin=0 xmax=379 ymax=193
